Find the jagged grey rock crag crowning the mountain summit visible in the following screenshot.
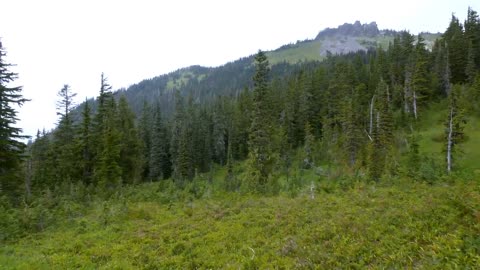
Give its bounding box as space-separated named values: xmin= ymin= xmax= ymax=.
xmin=315 ymin=21 xmax=380 ymax=40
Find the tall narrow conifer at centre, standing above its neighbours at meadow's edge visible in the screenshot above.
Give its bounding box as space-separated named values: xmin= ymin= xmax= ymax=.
xmin=247 ymin=51 xmax=271 ymax=191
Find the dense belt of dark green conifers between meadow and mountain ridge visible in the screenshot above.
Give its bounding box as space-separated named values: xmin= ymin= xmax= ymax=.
xmin=0 ymin=9 xmax=480 ymax=200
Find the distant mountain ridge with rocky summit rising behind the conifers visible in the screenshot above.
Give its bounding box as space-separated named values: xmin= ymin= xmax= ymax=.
xmin=80 ymin=21 xmax=440 ymax=118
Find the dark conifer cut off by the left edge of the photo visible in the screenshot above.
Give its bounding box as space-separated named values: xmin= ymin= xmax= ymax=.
xmin=0 ymin=41 xmax=28 ymax=196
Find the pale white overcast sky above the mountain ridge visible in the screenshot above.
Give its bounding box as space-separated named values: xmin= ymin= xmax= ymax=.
xmin=0 ymin=0 xmax=480 ymax=136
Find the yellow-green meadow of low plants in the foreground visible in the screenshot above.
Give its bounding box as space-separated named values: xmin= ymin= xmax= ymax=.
xmin=0 ymin=177 xmax=480 ymax=269
